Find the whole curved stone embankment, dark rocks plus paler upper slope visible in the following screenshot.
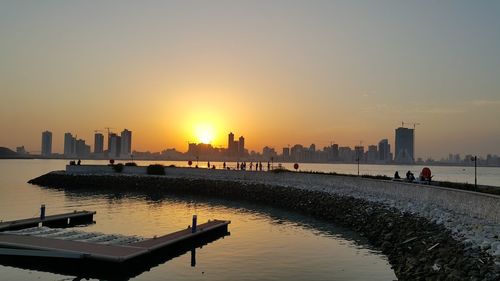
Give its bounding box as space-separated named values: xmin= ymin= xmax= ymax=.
xmin=30 ymin=165 xmax=500 ymax=280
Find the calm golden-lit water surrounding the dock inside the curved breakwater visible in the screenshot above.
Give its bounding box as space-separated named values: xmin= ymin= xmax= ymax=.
xmin=0 ymin=160 xmax=396 ymax=280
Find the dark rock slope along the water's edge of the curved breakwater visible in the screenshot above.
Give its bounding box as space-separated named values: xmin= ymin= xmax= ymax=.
xmin=30 ymin=171 xmax=500 ymax=280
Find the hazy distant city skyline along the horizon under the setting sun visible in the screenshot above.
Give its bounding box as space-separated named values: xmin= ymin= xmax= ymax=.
xmin=16 ymin=123 xmax=500 ymax=166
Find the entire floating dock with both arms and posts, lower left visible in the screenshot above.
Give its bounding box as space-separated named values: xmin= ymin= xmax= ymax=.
xmin=0 ymin=209 xmax=231 ymax=280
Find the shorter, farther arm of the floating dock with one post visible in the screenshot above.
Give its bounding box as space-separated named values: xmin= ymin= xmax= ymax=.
xmin=0 ymin=211 xmax=96 ymax=231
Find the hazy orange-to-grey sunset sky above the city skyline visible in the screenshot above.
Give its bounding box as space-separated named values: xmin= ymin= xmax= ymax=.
xmin=0 ymin=0 xmax=500 ymax=157
